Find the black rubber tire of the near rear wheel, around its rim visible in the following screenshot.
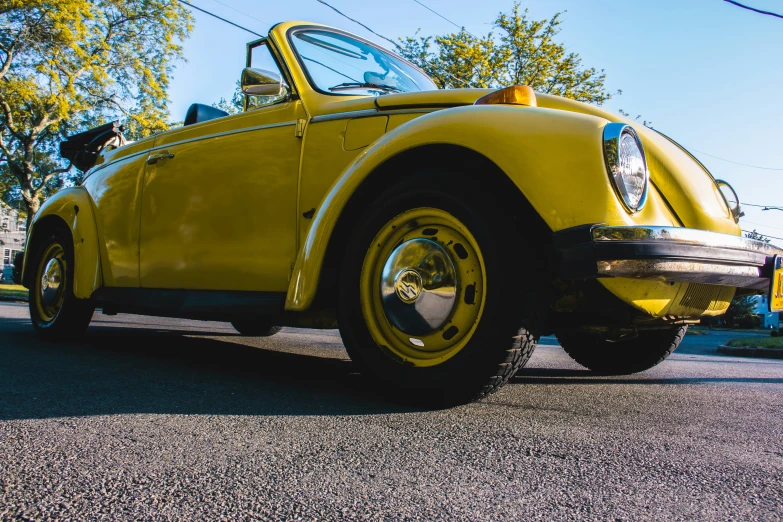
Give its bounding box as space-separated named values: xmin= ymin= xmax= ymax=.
xmin=29 ymin=225 xmax=95 ymax=342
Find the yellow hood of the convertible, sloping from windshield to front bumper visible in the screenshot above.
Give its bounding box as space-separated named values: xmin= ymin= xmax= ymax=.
xmin=375 ymin=89 xmax=741 ymax=235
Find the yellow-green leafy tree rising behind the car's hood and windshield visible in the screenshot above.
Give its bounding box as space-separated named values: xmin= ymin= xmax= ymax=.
xmin=398 ymin=2 xmax=620 ymax=105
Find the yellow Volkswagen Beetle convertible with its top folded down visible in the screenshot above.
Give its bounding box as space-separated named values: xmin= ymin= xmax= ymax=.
xmin=22 ymin=22 xmax=783 ymax=404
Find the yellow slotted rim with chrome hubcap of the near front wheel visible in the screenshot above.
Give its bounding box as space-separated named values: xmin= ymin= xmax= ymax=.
xmin=360 ymin=208 xmax=486 ymax=367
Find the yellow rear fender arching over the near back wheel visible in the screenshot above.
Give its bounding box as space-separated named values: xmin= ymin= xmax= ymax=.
xmin=22 ymin=187 xmax=101 ymax=299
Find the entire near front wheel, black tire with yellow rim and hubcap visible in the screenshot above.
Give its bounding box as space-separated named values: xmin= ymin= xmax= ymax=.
xmin=338 ymin=175 xmax=537 ymax=404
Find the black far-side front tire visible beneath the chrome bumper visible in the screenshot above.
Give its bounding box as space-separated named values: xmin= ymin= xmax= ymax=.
xmin=557 ymin=326 xmax=688 ymax=375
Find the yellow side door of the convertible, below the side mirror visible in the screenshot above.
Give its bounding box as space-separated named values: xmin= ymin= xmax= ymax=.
xmin=140 ymin=44 xmax=304 ymax=292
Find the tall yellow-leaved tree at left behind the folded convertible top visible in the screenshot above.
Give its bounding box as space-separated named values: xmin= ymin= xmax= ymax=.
xmin=0 ymin=0 xmax=193 ymax=226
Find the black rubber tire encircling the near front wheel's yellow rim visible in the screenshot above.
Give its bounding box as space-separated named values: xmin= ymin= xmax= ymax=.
xmin=338 ymin=173 xmax=538 ymax=406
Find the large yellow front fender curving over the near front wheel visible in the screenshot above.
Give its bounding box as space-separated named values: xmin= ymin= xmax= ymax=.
xmin=286 ymin=105 xmax=679 ymax=311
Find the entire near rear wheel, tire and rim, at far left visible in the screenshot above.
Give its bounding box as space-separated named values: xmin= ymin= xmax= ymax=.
xmin=29 ymin=230 xmax=95 ymax=341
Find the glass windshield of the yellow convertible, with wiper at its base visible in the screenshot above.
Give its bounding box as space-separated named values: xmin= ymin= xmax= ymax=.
xmin=292 ymin=29 xmax=438 ymax=96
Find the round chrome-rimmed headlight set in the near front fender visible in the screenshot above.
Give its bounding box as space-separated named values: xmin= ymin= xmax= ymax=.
xmin=604 ymin=123 xmax=649 ymax=212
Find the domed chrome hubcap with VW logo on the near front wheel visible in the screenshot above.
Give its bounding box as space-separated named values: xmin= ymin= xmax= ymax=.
xmin=381 ymin=239 xmax=457 ymax=335
